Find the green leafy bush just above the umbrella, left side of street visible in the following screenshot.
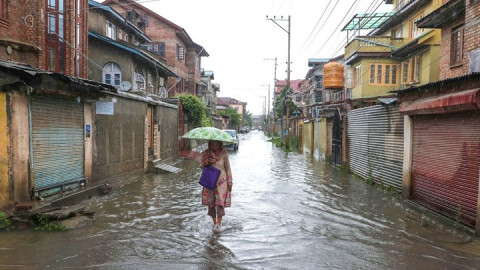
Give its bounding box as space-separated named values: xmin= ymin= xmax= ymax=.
xmin=178 ymin=95 xmax=213 ymax=127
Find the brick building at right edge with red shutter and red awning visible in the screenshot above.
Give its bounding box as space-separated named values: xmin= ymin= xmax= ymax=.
xmin=395 ymin=0 xmax=480 ymax=233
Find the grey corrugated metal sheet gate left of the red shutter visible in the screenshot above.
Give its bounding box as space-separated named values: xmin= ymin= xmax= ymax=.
xmin=347 ymin=105 xmax=403 ymax=190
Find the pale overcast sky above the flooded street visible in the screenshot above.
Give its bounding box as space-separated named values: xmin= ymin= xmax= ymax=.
xmin=143 ymin=0 xmax=392 ymax=114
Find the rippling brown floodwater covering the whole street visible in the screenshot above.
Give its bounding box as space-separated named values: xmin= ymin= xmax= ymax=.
xmin=0 ymin=131 xmax=480 ymax=270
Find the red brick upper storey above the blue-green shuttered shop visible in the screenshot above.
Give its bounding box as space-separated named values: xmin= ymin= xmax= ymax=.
xmin=0 ymin=0 xmax=88 ymax=78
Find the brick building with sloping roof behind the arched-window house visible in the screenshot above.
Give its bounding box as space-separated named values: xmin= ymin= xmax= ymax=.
xmin=103 ymin=0 xmax=209 ymax=97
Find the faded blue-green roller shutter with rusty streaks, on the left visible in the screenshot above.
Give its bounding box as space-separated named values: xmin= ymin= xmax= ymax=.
xmin=30 ymin=97 xmax=84 ymax=196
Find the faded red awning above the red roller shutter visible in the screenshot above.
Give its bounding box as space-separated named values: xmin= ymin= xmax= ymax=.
xmin=399 ymin=88 xmax=480 ymax=115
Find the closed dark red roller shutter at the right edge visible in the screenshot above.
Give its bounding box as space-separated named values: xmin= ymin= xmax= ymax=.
xmin=412 ymin=112 xmax=480 ymax=227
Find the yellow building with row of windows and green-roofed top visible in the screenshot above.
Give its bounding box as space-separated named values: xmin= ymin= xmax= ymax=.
xmin=343 ymin=0 xmax=441 ymax=99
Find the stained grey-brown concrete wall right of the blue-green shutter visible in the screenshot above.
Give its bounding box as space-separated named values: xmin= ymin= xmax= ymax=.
xmin=93 ymin=96 xmax=147 ymax=181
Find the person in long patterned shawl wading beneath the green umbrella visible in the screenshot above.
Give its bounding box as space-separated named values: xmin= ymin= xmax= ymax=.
xmin=200 ymin=141 xmax=233 ymax=233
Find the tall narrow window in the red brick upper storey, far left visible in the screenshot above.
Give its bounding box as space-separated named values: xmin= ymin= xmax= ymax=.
xmin=45 ymin=0 xmax=65 ymax=73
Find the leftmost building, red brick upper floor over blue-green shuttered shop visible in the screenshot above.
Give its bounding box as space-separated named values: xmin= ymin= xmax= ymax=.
xmin=0 ymin=0 xmax=116 ymax=205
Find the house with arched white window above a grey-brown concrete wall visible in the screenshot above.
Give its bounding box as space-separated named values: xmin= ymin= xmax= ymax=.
xmin=88 ymin=1 xmax=178 ymax=180
